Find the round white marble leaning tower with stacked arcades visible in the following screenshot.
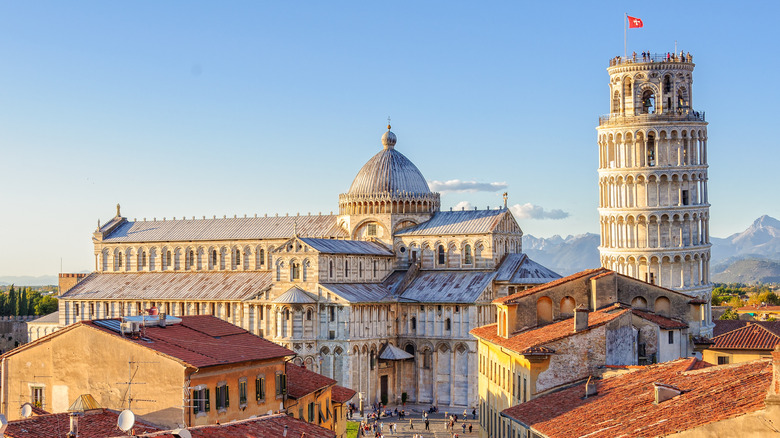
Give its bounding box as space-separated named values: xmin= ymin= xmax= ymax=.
xmin=597 ymin=53 xmax=713 ymax=335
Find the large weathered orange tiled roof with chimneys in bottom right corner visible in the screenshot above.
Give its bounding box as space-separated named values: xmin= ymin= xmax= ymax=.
xmin=502 ymin=359 xmax=772 ymax=438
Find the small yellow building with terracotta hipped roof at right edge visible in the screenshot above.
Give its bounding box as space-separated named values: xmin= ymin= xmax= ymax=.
xmin=702 ymin=321 xmax=780 ymax=365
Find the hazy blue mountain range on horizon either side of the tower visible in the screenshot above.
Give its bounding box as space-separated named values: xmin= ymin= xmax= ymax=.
xmin=523 ymin=215 xmax=780 ymax=283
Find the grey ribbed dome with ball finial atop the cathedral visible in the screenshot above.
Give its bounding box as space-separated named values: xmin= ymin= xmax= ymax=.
xmin=347 ymin=126 xmax=431 ymax=195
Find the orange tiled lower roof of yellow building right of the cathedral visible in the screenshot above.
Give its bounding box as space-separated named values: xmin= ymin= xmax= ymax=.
xmin=469 ymin=306 xmax=630 ymax=354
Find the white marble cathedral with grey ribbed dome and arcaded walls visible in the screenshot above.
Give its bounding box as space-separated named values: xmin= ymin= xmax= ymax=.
xmin=59 ymin=126 xmax=560 ymax=407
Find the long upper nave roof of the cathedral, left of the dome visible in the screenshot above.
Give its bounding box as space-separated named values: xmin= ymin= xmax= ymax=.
xmin=98 ymin=215 xmax=348 ymax=243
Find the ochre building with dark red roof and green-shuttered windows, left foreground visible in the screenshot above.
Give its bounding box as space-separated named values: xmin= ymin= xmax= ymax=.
xmin=0 ymin=315 xmax=293 ymax=428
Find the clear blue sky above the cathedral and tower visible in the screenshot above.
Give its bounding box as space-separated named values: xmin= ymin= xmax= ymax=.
xmin=0 ymin=1 xmax=780 ymax=275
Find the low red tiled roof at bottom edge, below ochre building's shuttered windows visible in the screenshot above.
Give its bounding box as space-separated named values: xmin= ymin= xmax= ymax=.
xmin=129 ymin=414 xmax=336 ymax=438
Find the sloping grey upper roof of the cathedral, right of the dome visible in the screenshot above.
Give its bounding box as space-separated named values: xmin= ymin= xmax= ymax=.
xmin=395 ymin=209 xmax=509 ymax=236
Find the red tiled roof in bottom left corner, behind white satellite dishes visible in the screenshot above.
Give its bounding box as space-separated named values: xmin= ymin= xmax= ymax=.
xmin=5 ymin=409 xmax=162 ymax=438
